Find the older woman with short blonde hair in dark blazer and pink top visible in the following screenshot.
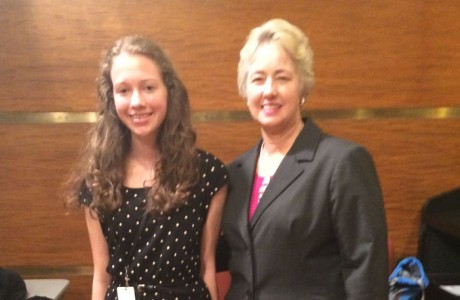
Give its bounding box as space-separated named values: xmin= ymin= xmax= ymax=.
xmin=223 ymin=19 xmax=388 ymax=300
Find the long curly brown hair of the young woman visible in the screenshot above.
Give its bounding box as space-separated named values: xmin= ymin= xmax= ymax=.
xmin=66 ymin=36 xmax=199 ymax=216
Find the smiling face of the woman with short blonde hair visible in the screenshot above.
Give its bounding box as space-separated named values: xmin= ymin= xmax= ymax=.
xmin=246 ymin=43 xmax=302 ymax=132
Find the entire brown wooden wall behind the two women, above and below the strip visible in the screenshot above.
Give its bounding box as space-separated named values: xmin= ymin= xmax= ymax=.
xmin=0 ymin=0 xmax=460 ymax=299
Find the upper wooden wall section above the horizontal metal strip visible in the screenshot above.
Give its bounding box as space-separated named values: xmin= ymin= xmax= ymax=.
xmin=0 ymin=0 xmax=460 ymax=111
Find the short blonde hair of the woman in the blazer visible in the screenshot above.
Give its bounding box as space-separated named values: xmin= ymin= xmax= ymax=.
xmin=238 ymin=19 xmax=314 ymax=98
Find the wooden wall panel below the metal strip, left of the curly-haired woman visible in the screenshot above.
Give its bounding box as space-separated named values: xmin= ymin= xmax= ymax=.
xmin=0 ymin=124 xmax=91 ymax=266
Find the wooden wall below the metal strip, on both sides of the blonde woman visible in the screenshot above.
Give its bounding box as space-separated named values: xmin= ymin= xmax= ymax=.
xmin=197 ymin=119 xmax=460 ymax=257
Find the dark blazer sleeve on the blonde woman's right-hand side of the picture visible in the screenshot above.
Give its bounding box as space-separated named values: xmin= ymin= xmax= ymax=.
xmin=331 ymin=145 xmax=388 ymax=300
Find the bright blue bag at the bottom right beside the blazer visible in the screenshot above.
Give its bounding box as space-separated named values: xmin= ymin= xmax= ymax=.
xmin=388 ymin=257 xmax=429 ymax=300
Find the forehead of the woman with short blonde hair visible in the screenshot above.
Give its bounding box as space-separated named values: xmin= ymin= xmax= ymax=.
xmin=249 ymin=43 xmax=295 ymax=73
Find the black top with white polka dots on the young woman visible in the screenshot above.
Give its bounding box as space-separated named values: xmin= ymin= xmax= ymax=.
xmin=80 ymin=151 xmax=228 ymax=300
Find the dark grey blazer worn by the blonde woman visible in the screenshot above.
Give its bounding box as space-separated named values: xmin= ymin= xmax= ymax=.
xmin=222 ymin=120 xmax=388 ymax=300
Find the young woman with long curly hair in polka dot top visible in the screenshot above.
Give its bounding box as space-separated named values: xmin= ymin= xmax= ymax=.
xmin=67 ymin=36 xmax=227 ymax=300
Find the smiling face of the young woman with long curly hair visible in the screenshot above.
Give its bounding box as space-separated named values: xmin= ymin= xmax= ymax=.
xmin=110 ymin=52 xmax=168 ymax=141
